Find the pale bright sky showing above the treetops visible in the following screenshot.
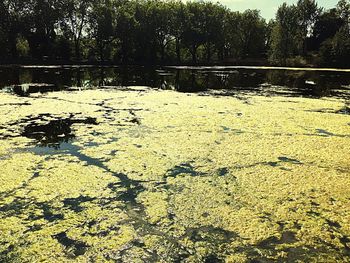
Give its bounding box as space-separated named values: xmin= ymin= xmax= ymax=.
xmin=197 ymin=0 xmax=338 ymax=20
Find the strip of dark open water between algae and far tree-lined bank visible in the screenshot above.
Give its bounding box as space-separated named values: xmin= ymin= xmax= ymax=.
xmin=0 ymin=66 xmax=350 ymax=99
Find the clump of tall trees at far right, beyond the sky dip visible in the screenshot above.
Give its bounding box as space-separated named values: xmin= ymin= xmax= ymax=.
xmin=270 ymin=0 xmax=350 ymax=66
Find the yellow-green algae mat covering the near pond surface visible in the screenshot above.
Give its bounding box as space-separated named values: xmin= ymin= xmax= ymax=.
xmin=0 ymin=88 xmax=350 ymax=263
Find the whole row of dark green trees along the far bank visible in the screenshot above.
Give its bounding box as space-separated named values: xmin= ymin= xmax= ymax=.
xmin=0 ymin=0 xmax=350 ymax=66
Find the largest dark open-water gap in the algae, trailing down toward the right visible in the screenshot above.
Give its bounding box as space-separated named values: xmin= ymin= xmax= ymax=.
xmin=12 ymin=114 xmax=143 ymax=210
